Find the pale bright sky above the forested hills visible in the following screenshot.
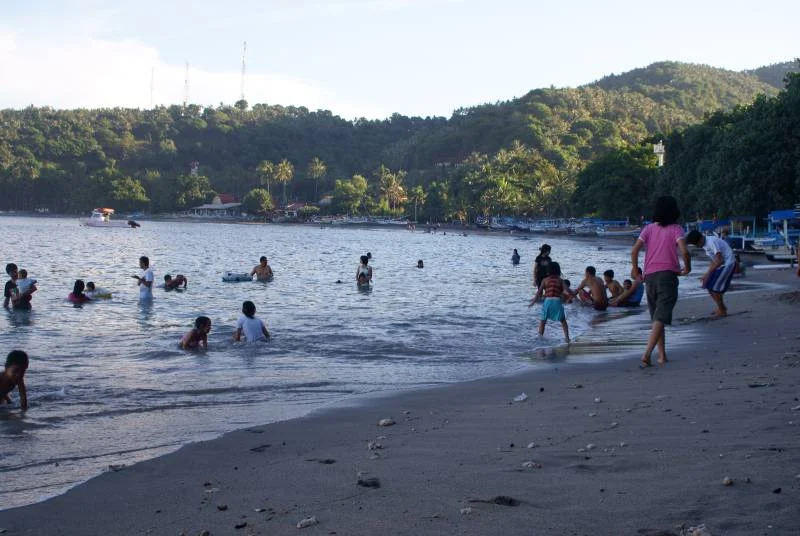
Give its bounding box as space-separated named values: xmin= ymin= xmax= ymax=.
xmin=0 ymin=0 xmax=800 ymax=119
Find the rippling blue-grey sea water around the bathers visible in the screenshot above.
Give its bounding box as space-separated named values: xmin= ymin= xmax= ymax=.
xmin=0 ymin=217 xmax=692 ymax=508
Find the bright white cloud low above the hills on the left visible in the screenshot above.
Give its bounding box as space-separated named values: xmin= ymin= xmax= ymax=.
xmin=0 ymin=29 xmax=388 ymax=118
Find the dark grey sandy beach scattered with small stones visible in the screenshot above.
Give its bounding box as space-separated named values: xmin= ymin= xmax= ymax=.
xmin=0 ymin=270 xmax=800 ymax=536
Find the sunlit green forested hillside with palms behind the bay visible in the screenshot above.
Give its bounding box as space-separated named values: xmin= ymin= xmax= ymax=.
xmin=0 ymin=62 xmax=797 ymax=220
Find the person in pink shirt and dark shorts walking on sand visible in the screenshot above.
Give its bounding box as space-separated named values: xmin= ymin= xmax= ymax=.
xmin=631 ymin=196 xmax=692 ymax=367
